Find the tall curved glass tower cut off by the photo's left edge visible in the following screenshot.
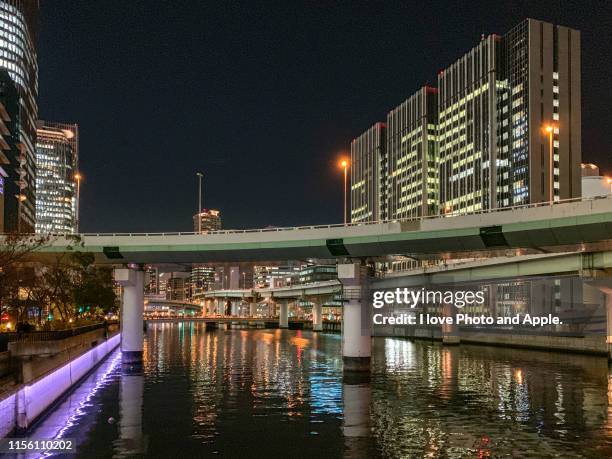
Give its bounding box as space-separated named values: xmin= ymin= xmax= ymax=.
xmin=0 ymin=0 xmax=39 ymax=232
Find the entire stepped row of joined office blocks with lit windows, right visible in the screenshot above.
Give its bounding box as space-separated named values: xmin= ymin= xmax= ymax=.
xmin=351 ymin=19 xmax=582 ymax=222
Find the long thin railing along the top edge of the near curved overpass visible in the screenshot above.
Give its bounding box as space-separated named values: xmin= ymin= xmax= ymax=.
xmin=21 ymin=194 xmax=612 ymax=237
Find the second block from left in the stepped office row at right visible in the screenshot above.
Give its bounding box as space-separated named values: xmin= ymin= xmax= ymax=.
xmin=388 ymin=86 xmax=439 ymax=220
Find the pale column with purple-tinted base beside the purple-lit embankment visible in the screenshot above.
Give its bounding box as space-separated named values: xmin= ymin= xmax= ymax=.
xmin=115 ymin=268 xmax=144 ymax=364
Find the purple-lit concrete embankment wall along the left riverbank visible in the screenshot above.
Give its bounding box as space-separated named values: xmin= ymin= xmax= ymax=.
xmin=0 ymin=329 xmax=120 ymax=438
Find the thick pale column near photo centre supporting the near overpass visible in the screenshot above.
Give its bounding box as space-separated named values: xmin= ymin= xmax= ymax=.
xmin=338 ymin=263 xmax=372 ymax=372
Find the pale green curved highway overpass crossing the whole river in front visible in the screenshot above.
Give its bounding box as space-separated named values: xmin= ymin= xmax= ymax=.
xmin=20 ymin=196 xmax=612 ymax=265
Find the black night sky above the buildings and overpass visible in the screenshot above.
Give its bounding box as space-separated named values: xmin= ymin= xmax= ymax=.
xmin=38 ymin=0 xmax=612 ymax=231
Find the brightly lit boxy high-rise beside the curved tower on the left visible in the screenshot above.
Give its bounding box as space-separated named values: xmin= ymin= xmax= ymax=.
xmin=36 ymin=121 xmax=79 ymax=234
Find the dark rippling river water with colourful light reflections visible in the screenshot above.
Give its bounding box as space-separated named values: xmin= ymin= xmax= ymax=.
xmin=16 ymin=323 xmax=612 ymax=458
